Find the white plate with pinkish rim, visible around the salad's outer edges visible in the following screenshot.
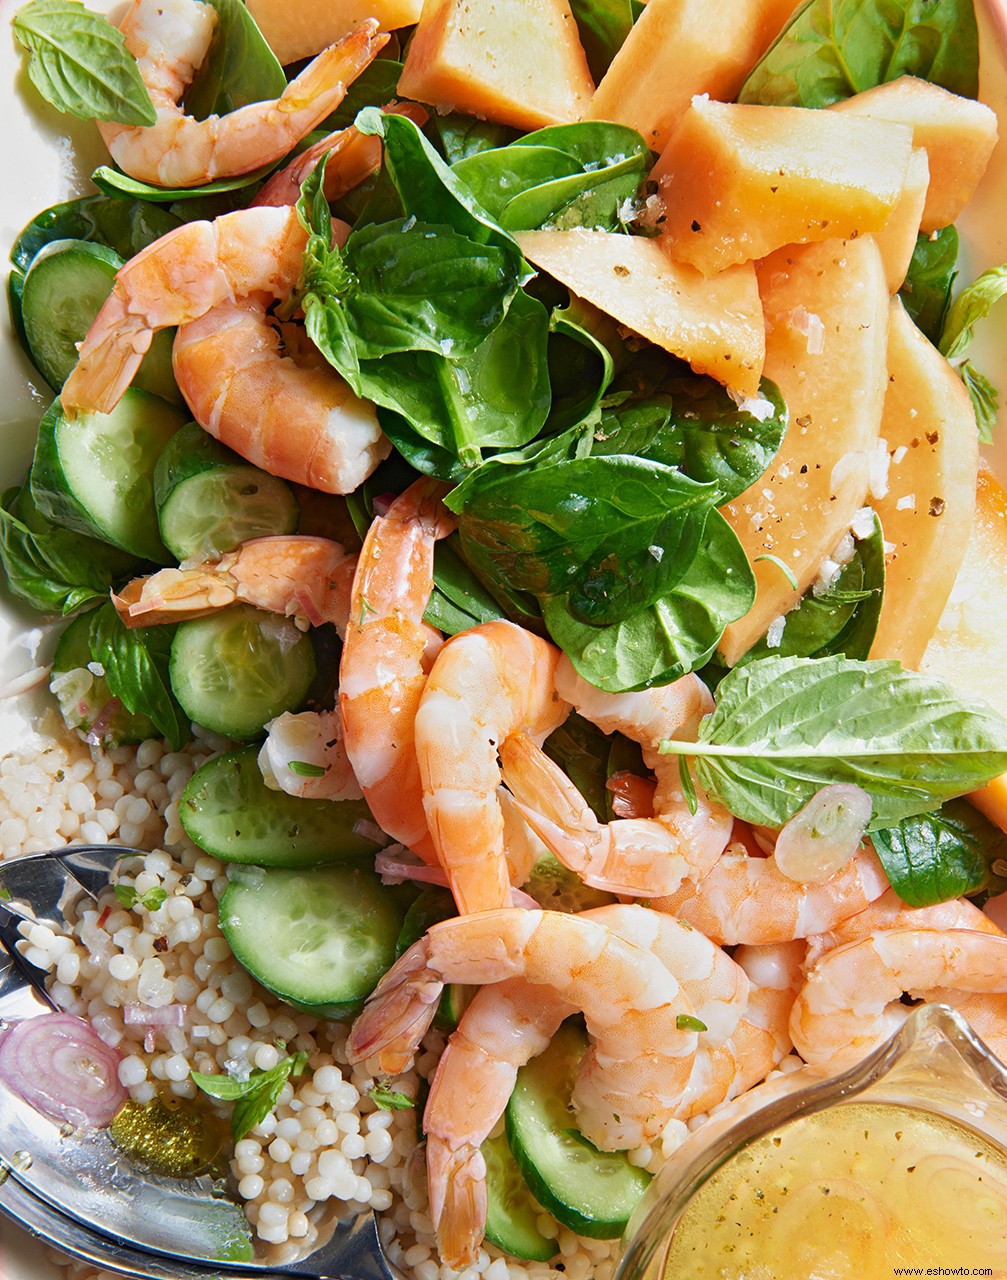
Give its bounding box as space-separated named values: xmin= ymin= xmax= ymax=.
xmin=0 ymin=0 xmax=1007 ymax=1280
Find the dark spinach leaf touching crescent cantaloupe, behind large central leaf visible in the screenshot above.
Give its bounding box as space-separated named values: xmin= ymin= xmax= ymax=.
xmin=591 ymin=376 xmax=788 ymax=506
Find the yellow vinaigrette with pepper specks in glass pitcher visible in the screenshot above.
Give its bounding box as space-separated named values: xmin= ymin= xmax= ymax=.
xmin=650 ymin=1102 xmax=1007 ymax=1280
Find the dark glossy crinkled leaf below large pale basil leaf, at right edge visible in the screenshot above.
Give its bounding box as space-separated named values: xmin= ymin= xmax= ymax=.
xmin=871 ymin=800 xmax=1007 ymax=906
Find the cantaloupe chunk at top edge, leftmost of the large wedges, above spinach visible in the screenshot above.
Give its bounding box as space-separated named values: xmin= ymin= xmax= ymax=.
xmin=399 ymin=0 xmax=595 ymax=129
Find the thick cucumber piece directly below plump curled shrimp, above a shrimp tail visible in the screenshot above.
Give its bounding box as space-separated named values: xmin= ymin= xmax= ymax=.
xmin=154 ymin=422 xmax=298 ymax=561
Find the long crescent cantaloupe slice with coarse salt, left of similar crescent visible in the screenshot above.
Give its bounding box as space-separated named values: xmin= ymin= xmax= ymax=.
xmin=720 ymin=236 xmax=888 ymax=663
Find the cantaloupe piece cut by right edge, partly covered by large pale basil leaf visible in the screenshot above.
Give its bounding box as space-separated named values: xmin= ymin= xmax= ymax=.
xmin=920 ymin=467 xmax=1007 ymax=831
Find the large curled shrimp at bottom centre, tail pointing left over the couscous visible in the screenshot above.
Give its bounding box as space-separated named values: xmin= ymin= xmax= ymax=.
xmin=347 ymin=908 xmax=696 ymax=1151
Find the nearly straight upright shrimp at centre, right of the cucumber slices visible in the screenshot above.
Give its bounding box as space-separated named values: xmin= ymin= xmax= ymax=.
xmin=339 ymin=480 xmax=454 ymax=863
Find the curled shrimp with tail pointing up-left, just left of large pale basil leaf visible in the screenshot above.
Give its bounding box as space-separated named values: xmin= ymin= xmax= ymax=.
xmin=500 ymin=657 xmax=733 ymax=897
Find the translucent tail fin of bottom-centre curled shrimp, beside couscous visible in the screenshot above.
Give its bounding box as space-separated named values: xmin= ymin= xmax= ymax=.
xmin=347 ymin=942 xmax=444 ymax=1075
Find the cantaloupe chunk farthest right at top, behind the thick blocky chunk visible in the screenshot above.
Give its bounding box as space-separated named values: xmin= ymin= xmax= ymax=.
xmin=829 ymin=76 xmax=997 ymax=232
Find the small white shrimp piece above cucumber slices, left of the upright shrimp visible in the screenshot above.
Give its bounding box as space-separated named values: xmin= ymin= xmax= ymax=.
xmin=258 ymin=710 xmax=363 ymax=800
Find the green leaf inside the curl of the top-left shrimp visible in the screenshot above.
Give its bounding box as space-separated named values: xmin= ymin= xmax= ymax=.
xmin=186 ymin=0 xmax=287 ymax=120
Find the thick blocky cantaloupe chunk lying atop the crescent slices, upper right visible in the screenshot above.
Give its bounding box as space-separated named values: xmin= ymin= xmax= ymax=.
xmin=651 ymin=97 xmax=912 ymax=275
